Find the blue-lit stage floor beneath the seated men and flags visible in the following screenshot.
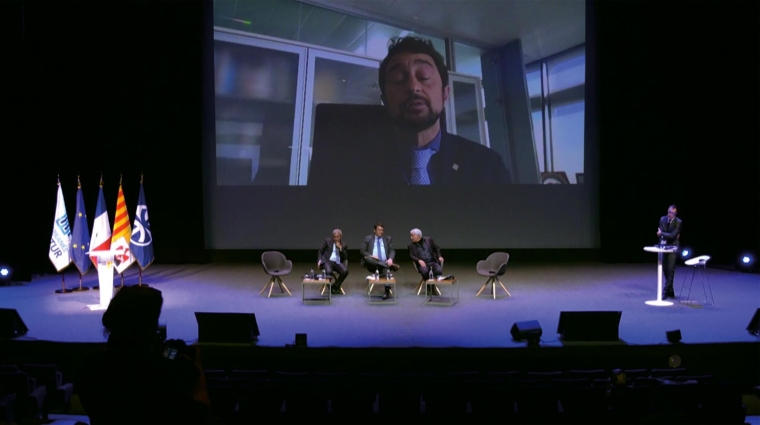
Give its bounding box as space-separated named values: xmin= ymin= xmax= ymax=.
xmin=0 ymin=261 xmax=760 ymax=348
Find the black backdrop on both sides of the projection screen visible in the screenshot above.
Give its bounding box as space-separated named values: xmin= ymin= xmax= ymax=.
xmin=0 ymin=0 xmax=760 ymax=279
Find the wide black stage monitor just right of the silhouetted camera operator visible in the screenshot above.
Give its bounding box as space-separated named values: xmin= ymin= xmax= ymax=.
xmin=195 ymin=311 xmax=259 ymax=344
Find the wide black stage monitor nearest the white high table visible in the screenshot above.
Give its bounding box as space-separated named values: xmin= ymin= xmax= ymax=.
xmin=557 ymin=311 xmax=623 ymax=341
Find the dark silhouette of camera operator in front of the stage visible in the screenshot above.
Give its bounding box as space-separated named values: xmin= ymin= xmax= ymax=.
xmin=75 ymin=286 xmax=210 ymax=425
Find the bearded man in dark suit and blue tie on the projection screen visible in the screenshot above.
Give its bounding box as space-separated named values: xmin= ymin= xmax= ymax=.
xmin=379 ymin=37 xmax=511 ymax=185
